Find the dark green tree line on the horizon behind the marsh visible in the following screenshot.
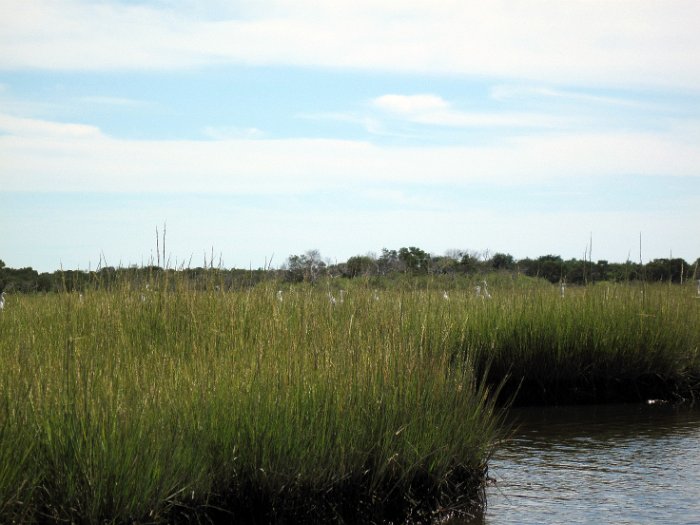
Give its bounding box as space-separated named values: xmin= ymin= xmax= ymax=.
xmin=0 ymin=250 xmax=700 ymax=293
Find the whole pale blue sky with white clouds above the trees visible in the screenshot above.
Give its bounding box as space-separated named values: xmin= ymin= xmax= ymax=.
xmin=0 ymin=0 xmax=700 ymax=271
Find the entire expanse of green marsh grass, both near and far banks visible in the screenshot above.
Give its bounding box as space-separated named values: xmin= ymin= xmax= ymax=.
xmin=0 ymin=272 xmax=700 ymax=523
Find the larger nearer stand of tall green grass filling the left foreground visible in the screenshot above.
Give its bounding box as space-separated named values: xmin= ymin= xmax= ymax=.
xmin=0 ymin=274 xmax=500 ymax=523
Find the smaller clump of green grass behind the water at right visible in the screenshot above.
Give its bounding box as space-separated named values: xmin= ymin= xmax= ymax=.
xmin=453 ymin=284 xmax=700 ymax=404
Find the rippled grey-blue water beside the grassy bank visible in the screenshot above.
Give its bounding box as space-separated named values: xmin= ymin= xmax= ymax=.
xmin=470 ymin=405 xmax=700 ymax=525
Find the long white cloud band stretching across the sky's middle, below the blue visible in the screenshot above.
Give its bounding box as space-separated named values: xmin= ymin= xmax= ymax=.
xmin=0 ymin=115 xmax=700 ymax=194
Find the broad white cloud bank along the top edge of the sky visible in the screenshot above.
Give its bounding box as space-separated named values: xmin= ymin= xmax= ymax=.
xmin=0 ymin=0 xmax=700 ymax=88
